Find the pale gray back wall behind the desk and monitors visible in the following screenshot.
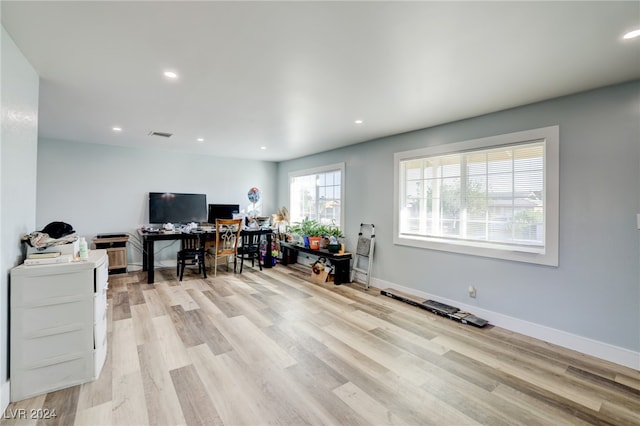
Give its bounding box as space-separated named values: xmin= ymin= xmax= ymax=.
xmin=36 ymin=139 xmax=277 ymax=266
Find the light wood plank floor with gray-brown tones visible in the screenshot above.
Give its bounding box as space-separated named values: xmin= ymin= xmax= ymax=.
xmin=0 ymin=265 xmax=640 ymax=426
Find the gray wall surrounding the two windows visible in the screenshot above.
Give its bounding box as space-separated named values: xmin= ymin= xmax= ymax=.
xmin=278 ymin=81 xmax=640 ymax=352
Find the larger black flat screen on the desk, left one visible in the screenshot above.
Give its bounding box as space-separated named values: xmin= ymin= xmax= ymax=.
xmin=149 ymin=192 xmax=207 ymax=223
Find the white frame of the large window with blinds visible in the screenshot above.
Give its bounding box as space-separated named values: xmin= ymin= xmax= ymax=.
xmin=393 ymin=126 xmax=560 ymax=266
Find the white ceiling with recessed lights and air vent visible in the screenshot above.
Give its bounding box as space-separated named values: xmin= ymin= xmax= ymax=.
xmin=1 ymin=0 xmax=640 ymax=161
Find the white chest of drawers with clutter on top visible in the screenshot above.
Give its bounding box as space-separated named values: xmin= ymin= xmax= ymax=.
xmin=9 ymin=250 xmax=109 ymax=401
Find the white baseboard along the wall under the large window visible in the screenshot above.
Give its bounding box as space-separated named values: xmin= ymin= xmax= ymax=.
xmin=371 ymin=277 xmax=640 ymax=370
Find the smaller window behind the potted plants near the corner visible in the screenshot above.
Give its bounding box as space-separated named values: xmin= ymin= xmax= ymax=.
xmin=289 ymin=163 xmax=345 ymax=227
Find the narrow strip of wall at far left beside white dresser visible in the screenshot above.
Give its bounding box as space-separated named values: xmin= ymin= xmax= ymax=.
xmin=0 ymin=27 xmax=38 ymax=411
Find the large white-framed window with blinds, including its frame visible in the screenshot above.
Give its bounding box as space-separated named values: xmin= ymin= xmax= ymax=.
xmin=394 ymin=126 xmax=558 ymax=265
